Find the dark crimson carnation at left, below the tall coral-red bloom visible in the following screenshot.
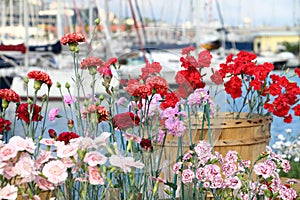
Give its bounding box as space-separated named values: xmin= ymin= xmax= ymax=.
xmin=16 ymin=103 xmax=43 ymax=124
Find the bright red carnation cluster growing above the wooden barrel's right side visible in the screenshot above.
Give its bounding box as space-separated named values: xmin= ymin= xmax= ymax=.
xmin=211 ymin=51 xmax=300 ymax=123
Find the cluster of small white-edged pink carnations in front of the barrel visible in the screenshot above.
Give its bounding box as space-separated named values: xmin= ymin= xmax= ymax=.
xmin=173 ymin=141 xmax=297 ymax=199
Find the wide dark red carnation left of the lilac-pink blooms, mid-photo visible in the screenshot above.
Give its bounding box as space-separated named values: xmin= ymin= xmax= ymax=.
xmin=113 ymin=112 xmax=140 ymax=129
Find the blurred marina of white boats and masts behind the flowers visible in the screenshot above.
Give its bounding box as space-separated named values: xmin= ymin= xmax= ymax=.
xmin=0 ymin=1 xmax=300 ymax=138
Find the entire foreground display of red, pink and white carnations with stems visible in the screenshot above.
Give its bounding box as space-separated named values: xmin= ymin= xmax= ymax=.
xmin=0 ymin=20 xmax=300 ymax=200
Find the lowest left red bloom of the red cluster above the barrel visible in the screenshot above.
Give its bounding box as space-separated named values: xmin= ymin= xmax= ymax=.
xmin=224 ymin=76 xmax=242 ymax=99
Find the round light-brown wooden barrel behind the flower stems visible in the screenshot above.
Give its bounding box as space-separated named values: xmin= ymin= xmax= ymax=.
xmin=162 ymin=113 xmax=273 ymax=184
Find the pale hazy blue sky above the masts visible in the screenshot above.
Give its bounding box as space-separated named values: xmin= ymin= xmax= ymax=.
xmin=65 ymin=0 xmax=300 ymax=27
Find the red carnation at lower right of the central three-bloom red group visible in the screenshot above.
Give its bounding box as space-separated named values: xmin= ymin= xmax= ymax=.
xmin=146 ymin=76 xmax=169 ymax=96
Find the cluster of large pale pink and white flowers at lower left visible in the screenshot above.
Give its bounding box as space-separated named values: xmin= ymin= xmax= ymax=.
xmin=0 ymin=132 xmax=144 ymax=199
